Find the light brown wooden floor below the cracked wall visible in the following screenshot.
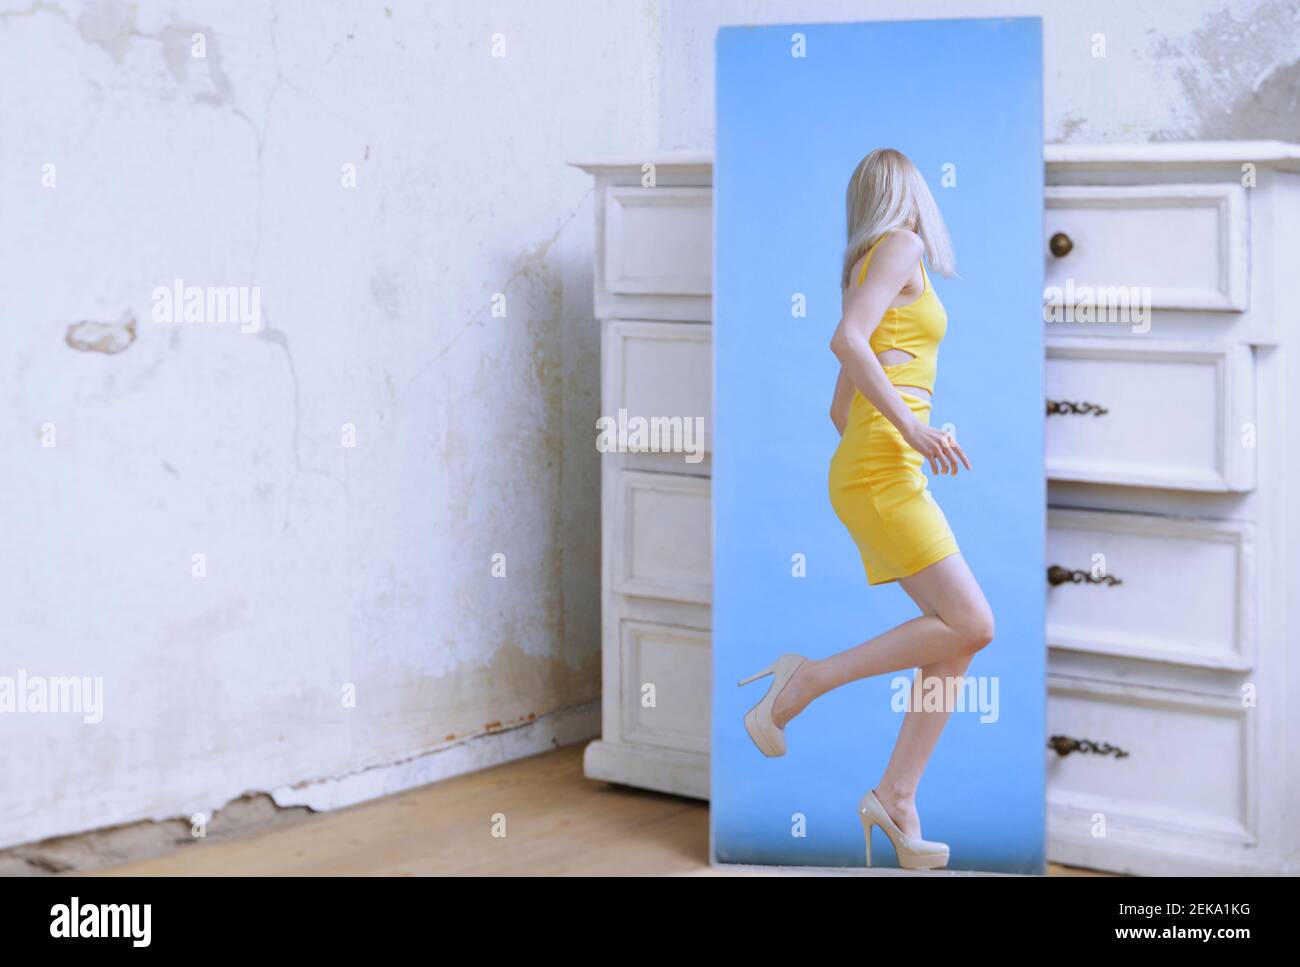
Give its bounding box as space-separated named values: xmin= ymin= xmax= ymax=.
xmin=101 ymin=745 xmax=1107 ymax=876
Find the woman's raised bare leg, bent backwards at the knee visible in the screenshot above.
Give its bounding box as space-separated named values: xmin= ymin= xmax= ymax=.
xmin=772 ymin=554 xmax=993 ymax=728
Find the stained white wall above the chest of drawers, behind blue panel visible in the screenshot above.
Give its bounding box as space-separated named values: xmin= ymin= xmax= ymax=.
xmin=659 ymin=0 xmax=1300 ymax=148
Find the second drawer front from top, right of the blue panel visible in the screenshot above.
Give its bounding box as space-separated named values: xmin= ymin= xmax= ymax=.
xmin=1045 ymin=338 xmax=1255 ymax=491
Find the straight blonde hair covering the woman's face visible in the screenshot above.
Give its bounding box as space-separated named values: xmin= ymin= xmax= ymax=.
xmin=840 ymin=148 xmax=957 ymax=289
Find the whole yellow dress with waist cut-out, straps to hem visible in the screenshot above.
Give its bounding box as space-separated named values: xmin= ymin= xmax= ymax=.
xmin=829 ymin=237 xmax=958 ymax=585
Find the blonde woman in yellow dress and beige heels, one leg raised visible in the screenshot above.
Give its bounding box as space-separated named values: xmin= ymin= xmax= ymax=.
xmin=741 ymin=148 xmax=993 ymax=868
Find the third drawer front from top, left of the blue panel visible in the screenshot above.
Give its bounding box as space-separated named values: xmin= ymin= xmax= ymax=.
xmin=614 ymin=471 xmax=712 ymax=604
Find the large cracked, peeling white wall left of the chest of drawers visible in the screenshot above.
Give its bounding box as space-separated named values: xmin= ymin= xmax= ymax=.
xmin=0 ymin=0 xmax=658 ymax=846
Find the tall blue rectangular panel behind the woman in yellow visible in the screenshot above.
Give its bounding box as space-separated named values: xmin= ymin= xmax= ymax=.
xmin=711 ymin=18 xmax=1047 ymax=872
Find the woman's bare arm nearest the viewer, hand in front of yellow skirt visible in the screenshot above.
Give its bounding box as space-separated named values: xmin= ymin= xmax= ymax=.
xmin=831 ymin=231 xmax=970 ymax=474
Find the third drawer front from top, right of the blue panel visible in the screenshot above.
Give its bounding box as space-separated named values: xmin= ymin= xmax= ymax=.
xmin=1047 ymin=509 xmax=1256 ymax=672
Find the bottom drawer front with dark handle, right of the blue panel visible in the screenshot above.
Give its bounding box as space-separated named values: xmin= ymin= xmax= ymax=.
xmin=1047 ymin=678 xmax=1256 ymax=847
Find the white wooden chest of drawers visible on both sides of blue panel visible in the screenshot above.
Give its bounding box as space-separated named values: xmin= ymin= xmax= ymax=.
xmin=580 ymin=142 xmax=1300 ymax=873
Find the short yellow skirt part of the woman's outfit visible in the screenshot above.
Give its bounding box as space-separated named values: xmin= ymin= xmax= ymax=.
xmin=829 ymin=391 xmax=958 ymax=585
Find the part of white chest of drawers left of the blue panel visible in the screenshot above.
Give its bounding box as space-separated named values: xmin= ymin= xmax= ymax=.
xmin=569 ymin=153 xmax=712 ymax=799
